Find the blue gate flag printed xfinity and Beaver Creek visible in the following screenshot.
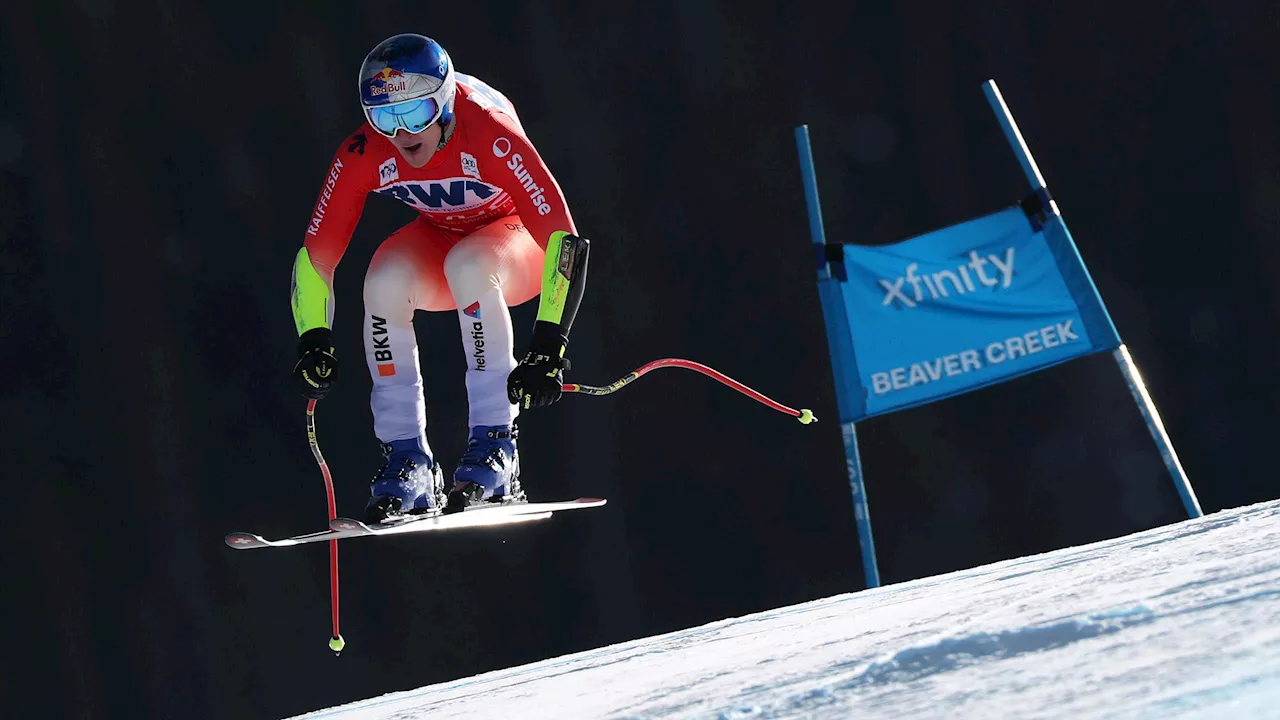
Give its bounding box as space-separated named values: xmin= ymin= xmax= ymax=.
xmin=841 ymin=206 xmax=1120 ymax=420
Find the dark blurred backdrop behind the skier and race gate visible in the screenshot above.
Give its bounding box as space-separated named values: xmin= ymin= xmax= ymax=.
xmin=0 ymin=0 xmax=1280 ymax=717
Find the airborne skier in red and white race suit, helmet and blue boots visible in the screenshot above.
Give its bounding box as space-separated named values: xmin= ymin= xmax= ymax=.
xmin=292 ymin=35 xmax=589 ymax=523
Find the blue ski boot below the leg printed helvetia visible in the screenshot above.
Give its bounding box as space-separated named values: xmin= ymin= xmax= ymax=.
xmin=444 ymin=424 xmax=525 ymax=512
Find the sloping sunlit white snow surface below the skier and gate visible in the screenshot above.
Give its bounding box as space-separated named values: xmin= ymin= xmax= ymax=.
xmin=288 ymin=502 xmax=1280 ymax=720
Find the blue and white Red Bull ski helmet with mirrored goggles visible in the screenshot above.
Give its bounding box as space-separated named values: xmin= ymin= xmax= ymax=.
xmin=360 ymin=33 xmax=458 ymax=149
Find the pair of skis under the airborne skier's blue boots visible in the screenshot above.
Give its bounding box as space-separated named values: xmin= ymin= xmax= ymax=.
xmin=223 ymin=497 xmax=607 ymax=550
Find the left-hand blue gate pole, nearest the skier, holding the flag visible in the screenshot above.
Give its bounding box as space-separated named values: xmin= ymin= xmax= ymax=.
xmin=796 ymin=126 xmax=879 ymax=588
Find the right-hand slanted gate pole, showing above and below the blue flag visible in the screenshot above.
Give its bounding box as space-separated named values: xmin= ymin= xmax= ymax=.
xmin=982 ymin=79 xmax=1204 ymax=518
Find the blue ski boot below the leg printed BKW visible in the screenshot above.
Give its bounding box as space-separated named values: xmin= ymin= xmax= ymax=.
xmin=365 ymin=437 xmax=444 ymax=523
